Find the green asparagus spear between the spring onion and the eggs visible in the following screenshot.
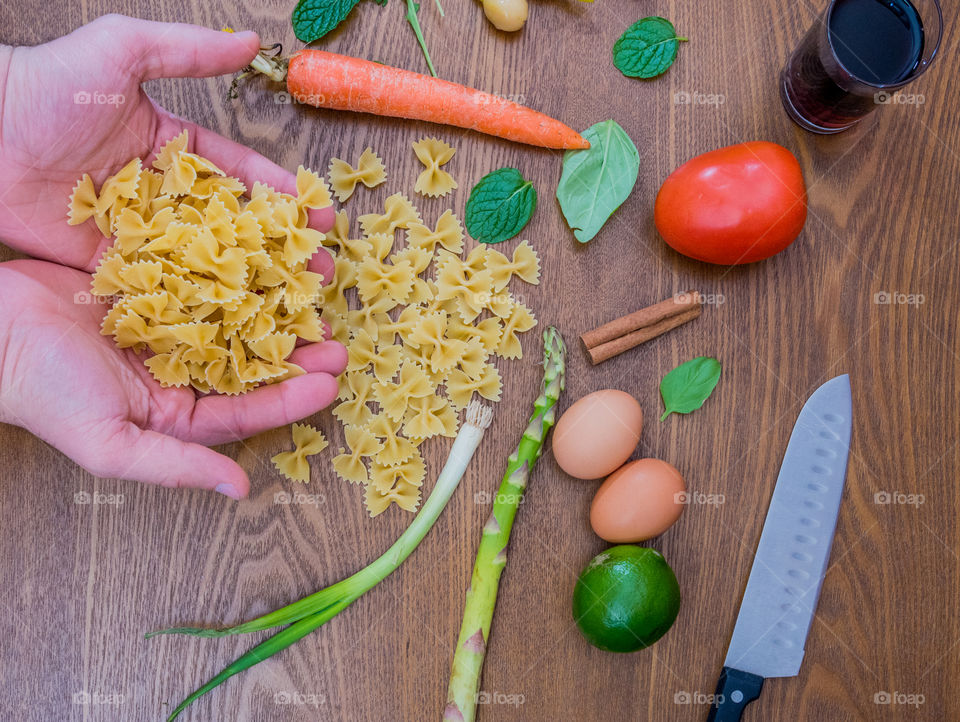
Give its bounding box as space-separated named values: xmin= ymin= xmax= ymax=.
xmin=443 ymin=327 xmax=565 ymax=722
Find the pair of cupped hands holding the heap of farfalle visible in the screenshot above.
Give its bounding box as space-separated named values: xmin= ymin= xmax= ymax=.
xmin=0 ymin=15 xmax=346 ymax=498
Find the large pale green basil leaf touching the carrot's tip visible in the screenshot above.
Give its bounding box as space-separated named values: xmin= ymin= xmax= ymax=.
xmin=557 ymin=120 xmax=640 ymax=243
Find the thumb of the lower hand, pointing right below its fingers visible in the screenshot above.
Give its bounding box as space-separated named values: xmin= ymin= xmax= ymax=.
xmin=91 ymin=423 xmax=250 ymax=499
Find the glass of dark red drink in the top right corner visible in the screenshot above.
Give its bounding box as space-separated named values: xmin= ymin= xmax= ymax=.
xmin=780 ymin=0 xmax=943 ymax=134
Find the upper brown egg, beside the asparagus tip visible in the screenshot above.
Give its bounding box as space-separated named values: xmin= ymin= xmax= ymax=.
xmin=553 ymin=389 xmax=643 ymax=479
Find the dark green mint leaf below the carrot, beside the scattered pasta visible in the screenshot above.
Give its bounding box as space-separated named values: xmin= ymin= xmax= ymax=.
xmin=463 ymin=168 xmax=537 ymax=243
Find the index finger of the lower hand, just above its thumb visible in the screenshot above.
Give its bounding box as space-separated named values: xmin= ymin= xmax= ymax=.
xmin=186 ymin=372 xmax=338 ymax=444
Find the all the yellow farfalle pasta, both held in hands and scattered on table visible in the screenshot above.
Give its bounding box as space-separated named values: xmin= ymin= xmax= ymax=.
xmin=70 ymin=134 xmax=540 ymax=516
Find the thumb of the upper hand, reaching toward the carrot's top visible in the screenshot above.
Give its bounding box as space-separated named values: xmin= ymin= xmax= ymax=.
xmin=90 ymin=15 xmax=260 ymax=80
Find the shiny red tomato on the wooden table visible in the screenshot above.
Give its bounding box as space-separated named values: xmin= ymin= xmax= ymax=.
xmin=653 ymin=140 xmax=807 ymax=266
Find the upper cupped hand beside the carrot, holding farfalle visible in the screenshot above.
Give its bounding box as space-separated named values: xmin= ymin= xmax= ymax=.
xmin=0 ymin=15 xmax=333 ymax=278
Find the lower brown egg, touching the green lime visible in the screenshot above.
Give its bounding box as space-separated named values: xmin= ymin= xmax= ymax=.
xmin=590 ymin=459 xmax=686 ymax=544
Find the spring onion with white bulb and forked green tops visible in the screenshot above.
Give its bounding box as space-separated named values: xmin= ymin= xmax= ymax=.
xmin=156 ymin=401 xmax=493 ymax=720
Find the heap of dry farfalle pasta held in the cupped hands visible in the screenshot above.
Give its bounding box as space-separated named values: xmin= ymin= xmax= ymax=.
xmin=69 ymin=131 xmax=332 ymax=394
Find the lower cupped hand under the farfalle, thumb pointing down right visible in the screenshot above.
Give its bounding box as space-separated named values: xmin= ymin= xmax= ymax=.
xmin=0 ymin=260 xmax=347 ymax=499
